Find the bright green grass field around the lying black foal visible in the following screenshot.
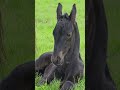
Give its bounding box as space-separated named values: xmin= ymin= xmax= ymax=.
xmin=35 ymin=0 xmax=85 ymax=90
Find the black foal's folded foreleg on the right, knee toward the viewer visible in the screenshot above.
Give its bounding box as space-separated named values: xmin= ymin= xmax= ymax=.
xmin=60 ymin=63 xmax=83 ymax=90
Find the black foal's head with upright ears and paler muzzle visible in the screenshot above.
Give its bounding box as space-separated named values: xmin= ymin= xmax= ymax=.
xmin=51 ymin=3 xmax=76 ymax=65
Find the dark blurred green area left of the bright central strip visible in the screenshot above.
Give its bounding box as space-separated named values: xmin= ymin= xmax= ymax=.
xmin=0 ymin=0 xmax=35 ymax=80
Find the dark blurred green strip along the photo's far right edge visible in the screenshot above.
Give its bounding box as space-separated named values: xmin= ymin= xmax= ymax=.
xmin=103 ymin=0 xmax=120 ymax=90
